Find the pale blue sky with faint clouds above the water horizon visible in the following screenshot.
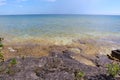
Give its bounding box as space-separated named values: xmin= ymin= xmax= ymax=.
xmin=0 ymin=0 xmax=120 ymax=15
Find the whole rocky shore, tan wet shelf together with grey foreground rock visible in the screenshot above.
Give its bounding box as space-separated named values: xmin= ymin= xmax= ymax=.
xmin=0 ymin=40 xmax=120 ymax=80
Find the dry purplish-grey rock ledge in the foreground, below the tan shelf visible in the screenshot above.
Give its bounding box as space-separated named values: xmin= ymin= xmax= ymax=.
xmin=0 ymin=51 xmax=120 ymax=80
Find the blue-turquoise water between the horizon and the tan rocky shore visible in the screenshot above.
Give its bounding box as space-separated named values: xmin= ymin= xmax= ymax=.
xmin=0 ymin=15 xmax=120 ymax=43
